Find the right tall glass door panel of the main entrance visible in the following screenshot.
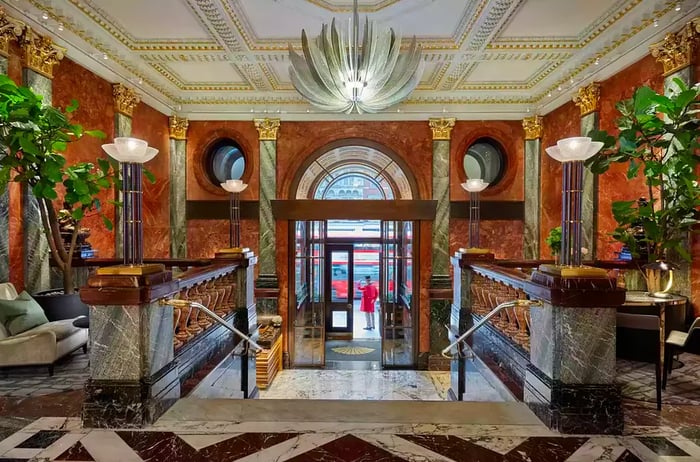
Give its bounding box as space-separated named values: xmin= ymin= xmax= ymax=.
xmin=379 ymin=221 xmax=415 ymax=367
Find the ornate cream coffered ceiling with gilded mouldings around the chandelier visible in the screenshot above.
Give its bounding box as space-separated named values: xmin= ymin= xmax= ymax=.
xmin=0 ymin=0 xmax=700 ymax=119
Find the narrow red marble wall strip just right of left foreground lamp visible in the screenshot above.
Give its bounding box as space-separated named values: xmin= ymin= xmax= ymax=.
xmin=131 ymin=103 xmax=170 ymax=258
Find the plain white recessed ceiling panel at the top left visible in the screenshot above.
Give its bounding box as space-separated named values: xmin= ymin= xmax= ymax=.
xmin=86 ymin=0 xmax=210 ymax=40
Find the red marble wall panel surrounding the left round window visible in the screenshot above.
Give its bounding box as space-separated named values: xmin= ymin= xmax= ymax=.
xmin=187 ymin=120 xmax=260 ymax=200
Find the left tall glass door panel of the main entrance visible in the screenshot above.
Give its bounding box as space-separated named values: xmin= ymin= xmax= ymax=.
xmin=292 ymin=221 xmax=325 ymax=366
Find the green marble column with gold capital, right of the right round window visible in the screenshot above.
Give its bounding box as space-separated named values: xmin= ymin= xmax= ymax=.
xmin=523 ymin=116 xmax=542 ymax=260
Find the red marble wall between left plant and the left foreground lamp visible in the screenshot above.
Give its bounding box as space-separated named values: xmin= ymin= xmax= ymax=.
xmin=53 ymin=58 xmax=114 ymax=258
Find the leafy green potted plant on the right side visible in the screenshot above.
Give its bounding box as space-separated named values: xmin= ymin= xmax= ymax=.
xmin=586 ymin=79 xmax=700 ymax=292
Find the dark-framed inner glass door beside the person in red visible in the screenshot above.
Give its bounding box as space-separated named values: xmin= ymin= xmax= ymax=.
xmin=326 ymin=244 xmax=354 ymax=336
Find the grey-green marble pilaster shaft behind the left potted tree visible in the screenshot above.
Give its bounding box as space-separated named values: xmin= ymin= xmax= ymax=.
xmin=22 ymin=68 xmax=55 ymax=293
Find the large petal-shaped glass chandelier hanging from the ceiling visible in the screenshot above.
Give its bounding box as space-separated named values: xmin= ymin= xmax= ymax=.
xmin=289 ymin=0 xmax=423 ymax=114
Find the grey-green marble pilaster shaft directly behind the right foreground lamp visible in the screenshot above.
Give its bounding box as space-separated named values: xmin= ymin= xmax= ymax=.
xmin=581 ymin=111 xmax=600 ymax=260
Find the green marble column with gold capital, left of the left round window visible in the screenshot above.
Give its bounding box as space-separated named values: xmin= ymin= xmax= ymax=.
xmin=170 ymin=116 xmax=188 ymax=258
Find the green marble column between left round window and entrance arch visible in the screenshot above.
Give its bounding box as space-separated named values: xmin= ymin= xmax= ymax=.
xmin=254 ymin=119 xmax=280 ymax=315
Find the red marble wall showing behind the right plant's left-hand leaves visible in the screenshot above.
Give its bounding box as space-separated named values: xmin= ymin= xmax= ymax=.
xmin=597 ymin=55 xmax=664 ymax=260
